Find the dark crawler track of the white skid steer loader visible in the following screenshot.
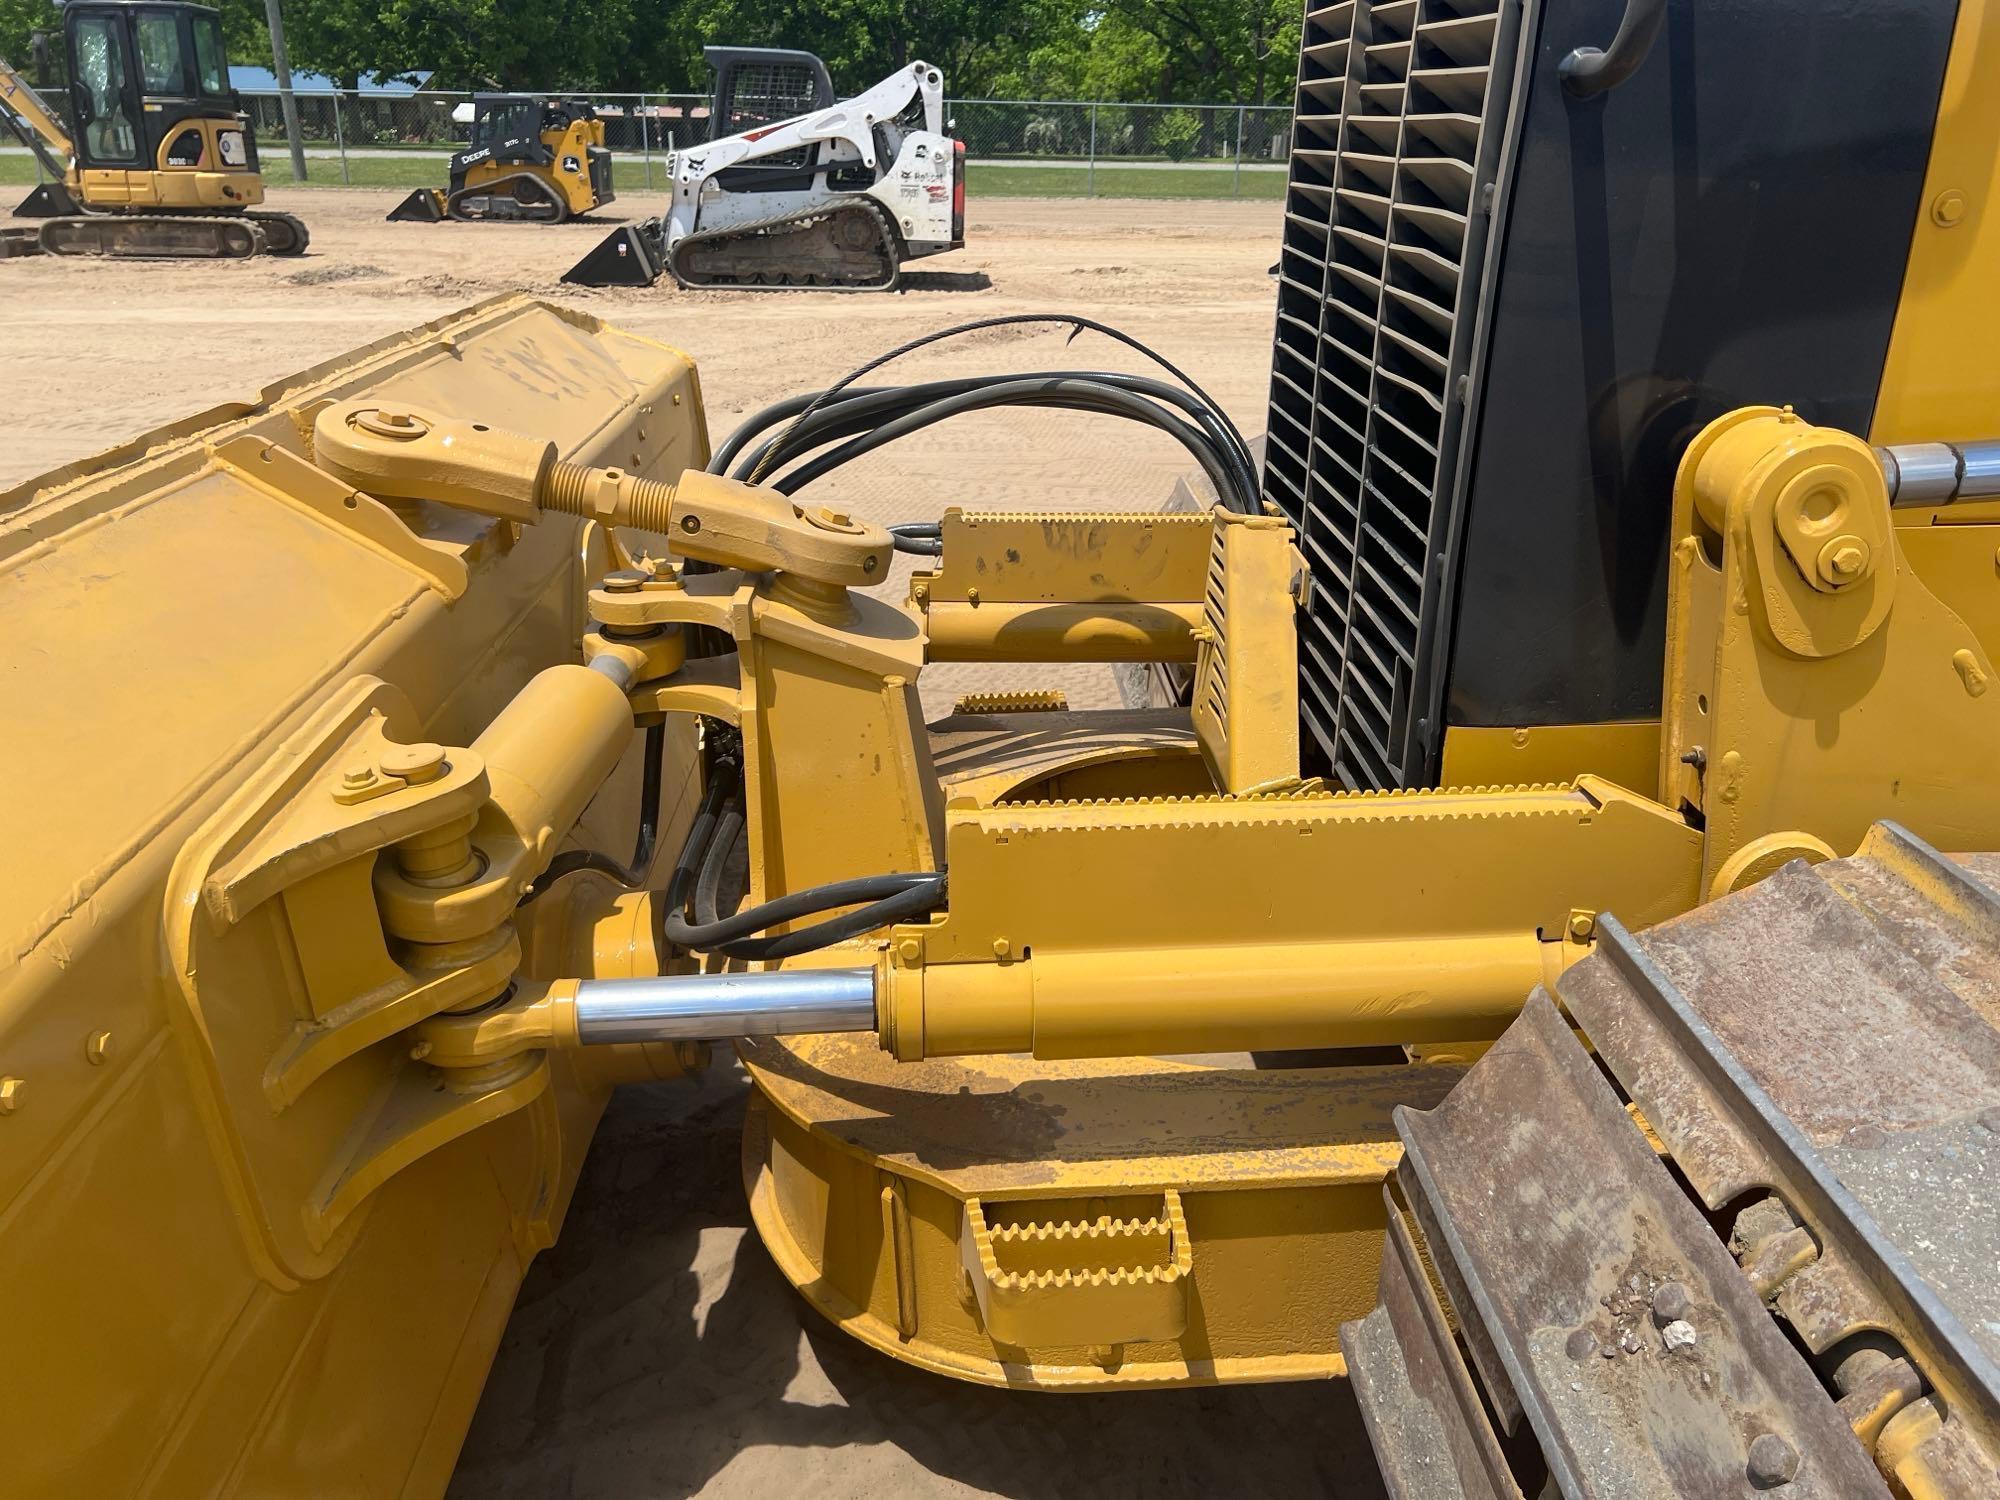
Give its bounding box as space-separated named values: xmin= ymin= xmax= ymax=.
xmin=668 ymin=198 xmax=902 ymax=292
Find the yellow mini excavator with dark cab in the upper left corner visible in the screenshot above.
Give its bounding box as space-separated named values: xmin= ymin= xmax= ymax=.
xmin=0 ymin=0 xmax=310 ymax=260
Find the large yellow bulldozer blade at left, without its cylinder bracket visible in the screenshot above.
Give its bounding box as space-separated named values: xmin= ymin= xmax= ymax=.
xmin=0 ymin=298 xmax=706 ymax=1496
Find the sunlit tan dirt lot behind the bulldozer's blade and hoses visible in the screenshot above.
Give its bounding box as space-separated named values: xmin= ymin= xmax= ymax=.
xmin=0 ymin=190 xmax=1280 ymax=712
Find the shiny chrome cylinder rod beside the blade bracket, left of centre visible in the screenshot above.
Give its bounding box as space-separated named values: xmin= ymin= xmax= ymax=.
xmin=576 ymin=968 xmax=876 ymax=1046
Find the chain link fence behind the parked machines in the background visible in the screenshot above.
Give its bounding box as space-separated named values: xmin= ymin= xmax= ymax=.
xmin=219 ymin=92 xmax=1292 ymax=198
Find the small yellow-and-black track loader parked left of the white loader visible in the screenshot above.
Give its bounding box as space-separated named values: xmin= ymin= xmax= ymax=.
xmin=388 ymin=94 xmax=618 ymax=224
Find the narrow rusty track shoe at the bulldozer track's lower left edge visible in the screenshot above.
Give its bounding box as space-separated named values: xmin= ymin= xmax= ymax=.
xmin=1340 ymin=1190 xmax=1520 ymax=1500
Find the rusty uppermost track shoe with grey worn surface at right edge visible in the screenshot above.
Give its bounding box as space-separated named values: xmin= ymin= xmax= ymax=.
xmin=1560 ymin=824 xmax=2000 ymax=1492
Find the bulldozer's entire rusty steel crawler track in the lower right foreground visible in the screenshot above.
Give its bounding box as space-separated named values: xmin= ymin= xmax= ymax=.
xmin=1340 ymin=824 xmax=2000 ymax=1498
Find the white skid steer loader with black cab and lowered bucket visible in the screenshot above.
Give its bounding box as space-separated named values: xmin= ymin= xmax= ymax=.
xmin=562 ymin=46 xmax=966 ymax=292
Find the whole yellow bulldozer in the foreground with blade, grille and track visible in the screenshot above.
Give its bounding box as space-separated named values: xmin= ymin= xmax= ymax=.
xmin=0 ymin=0 xmax=2000 ymax=1496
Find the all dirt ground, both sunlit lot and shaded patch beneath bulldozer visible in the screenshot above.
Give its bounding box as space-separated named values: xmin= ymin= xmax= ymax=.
xmin=0 ymin=192 xmax=1380 ymax=1500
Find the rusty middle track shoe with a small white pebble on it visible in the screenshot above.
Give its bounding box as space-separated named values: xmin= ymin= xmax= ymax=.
xmin=1398 ymin=990 xmax=1888 ymax=1498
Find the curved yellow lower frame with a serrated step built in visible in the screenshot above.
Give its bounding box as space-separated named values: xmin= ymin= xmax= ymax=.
xmin=742 ymin=1036 xmax=1460 ymax=1390
